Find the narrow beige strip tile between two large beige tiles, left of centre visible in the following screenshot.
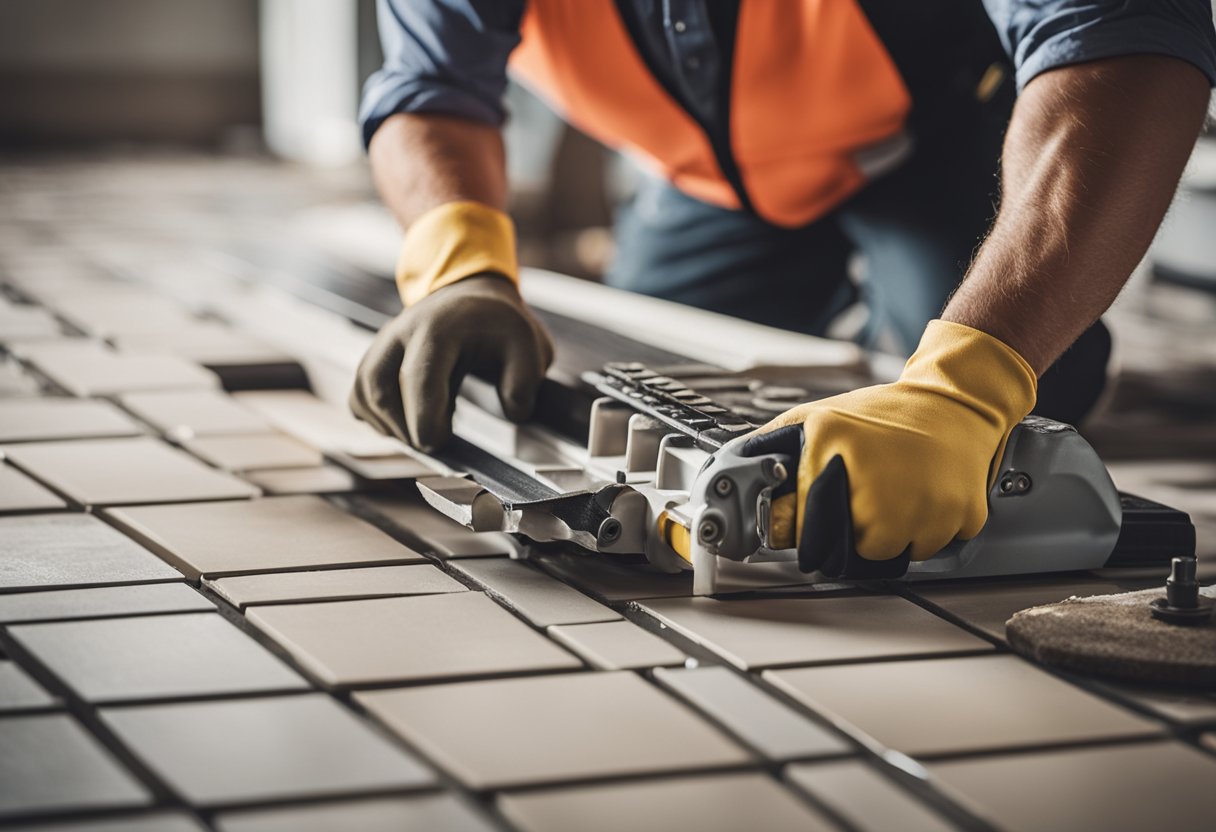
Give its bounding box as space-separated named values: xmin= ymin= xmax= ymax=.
xmin=206 ymin=563 xmax=468 ymax=609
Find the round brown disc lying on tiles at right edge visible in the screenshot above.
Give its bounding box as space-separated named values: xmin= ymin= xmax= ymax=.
xmin=1006 ymin=588 xmax=1216 ymax=687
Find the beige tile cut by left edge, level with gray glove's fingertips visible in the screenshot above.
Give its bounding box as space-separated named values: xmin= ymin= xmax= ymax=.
xmin=0 ymin=397 xmax=143 ymax=442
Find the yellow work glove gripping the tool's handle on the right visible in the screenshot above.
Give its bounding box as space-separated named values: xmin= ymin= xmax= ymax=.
xmin=760 ymin=321 xmax=1037 ymax=561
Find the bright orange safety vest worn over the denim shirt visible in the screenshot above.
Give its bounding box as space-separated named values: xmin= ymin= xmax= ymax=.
xmin=511 ymin=0 xmax=912 ymax=227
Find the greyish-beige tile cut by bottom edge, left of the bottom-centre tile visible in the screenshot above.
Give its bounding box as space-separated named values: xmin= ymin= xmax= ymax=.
xmin=216 ymin=794 xmax=495 ymax=832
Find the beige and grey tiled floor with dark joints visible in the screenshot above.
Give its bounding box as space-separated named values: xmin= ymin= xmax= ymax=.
xmin=0 ymin=154 xmax=1216 ymax=832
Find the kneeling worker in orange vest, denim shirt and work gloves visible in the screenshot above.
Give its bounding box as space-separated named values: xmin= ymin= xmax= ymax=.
xmin=351 ymin=0 xmax=1216 ymax=561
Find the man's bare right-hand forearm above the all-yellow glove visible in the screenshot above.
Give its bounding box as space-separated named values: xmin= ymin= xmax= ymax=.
xmin=942 ymin=56 xmax=1209 ymax=373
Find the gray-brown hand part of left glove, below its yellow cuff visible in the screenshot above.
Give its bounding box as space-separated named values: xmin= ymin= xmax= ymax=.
xmin=350 ymin=275 xmax=553 ymax=451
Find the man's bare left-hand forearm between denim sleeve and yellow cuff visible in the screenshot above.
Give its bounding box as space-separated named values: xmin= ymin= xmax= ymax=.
xmin=368 ymin=113 xmax=507 ymax=227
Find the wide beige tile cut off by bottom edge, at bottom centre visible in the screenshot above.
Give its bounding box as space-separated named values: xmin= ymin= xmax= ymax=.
xmin=499 ymin=774 xmax=837 ymax=832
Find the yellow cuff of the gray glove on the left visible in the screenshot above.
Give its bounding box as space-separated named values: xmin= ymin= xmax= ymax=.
xmin=396 ymin=201 xmax=519 ymax=307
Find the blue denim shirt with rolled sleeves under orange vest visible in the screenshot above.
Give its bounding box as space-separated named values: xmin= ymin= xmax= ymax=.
xmin=359 ymin=0 xmax=1216 ymax=142
